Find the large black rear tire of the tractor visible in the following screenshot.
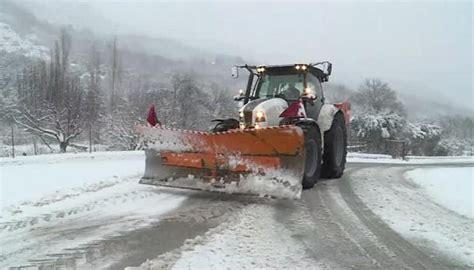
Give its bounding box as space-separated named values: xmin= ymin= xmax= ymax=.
xmin=322 ymin=113 xmax=347 ymax=179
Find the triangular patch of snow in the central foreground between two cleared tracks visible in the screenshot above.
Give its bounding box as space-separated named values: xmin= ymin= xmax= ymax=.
xmin=127 ymin=203 xmax=320 ymax=270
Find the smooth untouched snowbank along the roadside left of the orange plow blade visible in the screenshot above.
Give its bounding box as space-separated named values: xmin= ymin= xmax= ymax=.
xmin=0 ymin=151 xmax=144 ymax=208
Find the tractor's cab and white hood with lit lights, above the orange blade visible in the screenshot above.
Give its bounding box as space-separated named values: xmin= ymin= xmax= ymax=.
xmin=233 ymin=62 xmax=332 ymax=129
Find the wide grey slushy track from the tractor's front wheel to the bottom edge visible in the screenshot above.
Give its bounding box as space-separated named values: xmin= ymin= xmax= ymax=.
xmin=303 ymin=177 xmax=397 ymax=269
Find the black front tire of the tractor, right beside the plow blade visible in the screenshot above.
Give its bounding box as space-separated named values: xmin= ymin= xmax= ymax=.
xmin=303 ymin=126 xmax=322 ymax=189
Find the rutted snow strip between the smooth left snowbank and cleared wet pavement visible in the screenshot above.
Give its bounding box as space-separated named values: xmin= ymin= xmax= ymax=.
xmin=0 ymin=179 xmax=189 ymax=268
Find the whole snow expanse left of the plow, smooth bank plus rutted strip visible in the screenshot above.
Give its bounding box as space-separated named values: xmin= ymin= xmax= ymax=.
xmin=0 ymin=151 xmax=188 ymax=269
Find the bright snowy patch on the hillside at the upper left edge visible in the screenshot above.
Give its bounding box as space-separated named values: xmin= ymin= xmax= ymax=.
xmin=0 ymin=22 xmax=49 ymax=60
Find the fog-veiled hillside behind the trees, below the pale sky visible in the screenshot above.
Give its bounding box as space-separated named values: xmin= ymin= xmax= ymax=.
xmin=0 ymin=1 xmax=473 ymax=119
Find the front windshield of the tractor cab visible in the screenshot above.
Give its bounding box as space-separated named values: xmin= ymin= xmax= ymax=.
xmin=254 ymin=73 xmax=304 ymax=100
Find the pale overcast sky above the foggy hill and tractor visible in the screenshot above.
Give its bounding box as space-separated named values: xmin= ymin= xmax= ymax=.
xmin=31 ymin=0 xmax=474 ymax=107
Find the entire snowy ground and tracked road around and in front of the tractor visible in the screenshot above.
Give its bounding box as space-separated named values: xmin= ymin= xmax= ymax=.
xmin=0 ymin=152 xmax=474 ymax=269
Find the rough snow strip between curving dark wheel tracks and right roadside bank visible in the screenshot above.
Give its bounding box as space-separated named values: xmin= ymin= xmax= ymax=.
xmin=343 ymin=164 xmax=474 ymax=269
